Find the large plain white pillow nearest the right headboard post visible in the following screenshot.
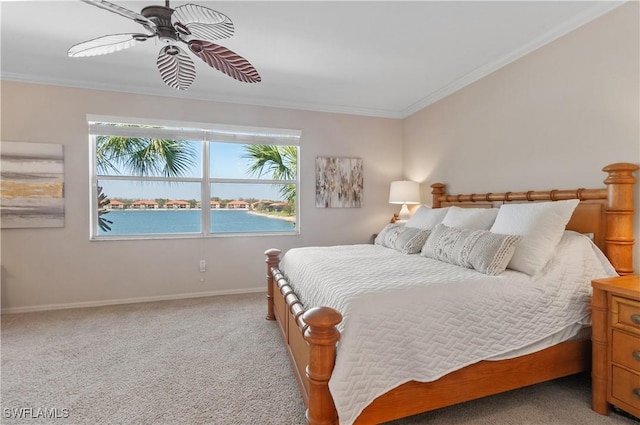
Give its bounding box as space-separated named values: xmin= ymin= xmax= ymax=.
xmin=491 ymin=199 xmax=580 ymax=276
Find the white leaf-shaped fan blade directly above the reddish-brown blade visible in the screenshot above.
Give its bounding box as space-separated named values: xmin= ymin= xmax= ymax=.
xmin=171 ymin=4 xmax=233 ymax=40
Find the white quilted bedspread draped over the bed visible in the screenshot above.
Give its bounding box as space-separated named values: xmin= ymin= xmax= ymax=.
xmin=280 ymin=232 xmax=616 ymax=425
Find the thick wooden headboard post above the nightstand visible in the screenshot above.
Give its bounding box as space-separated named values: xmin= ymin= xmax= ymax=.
xmin=602 ymin=162 xmax=638 ymax=275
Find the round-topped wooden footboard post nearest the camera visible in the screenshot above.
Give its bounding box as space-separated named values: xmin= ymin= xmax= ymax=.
xmin=302 ymin=307 xmax=342 ymax=425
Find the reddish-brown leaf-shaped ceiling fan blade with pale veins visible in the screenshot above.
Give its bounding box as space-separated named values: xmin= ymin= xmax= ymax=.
xmin=188 ymin=40 xmax=262 ymax=83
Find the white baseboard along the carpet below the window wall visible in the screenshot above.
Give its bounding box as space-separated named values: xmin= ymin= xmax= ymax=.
xmin=2 ymin=287 xmax=266 ymax=314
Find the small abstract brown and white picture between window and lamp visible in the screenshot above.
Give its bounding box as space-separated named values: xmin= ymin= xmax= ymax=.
xmin=316 ymin=156 xmax=363 ymax=208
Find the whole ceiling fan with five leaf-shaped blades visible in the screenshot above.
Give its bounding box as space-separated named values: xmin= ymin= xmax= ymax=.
xmin=67 ymin=0 xmax=262 ymax=90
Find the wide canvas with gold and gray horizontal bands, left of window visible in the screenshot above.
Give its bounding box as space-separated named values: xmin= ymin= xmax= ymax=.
xmin=0 ymin=142 xmax=64 ymax=229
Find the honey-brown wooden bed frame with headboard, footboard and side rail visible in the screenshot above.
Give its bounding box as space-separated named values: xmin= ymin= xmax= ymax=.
xmin=265 ymin=163 xmax=638 ymax=425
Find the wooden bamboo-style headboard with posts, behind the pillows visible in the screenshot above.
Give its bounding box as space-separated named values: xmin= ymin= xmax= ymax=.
xmin=431 ymin=162 xmax=639 ymax=275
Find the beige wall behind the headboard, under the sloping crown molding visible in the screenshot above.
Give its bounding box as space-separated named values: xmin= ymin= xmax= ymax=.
xmin=404 ymin=2 xmax=640 ymax=271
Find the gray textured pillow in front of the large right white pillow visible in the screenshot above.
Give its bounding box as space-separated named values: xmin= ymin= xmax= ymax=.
xmin=421 ymin=224 xmax=521 ymax=276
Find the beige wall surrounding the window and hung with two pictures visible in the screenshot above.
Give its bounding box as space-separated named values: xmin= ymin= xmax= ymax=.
xmin=1 ymin=82 xmax=402 ymax=311
